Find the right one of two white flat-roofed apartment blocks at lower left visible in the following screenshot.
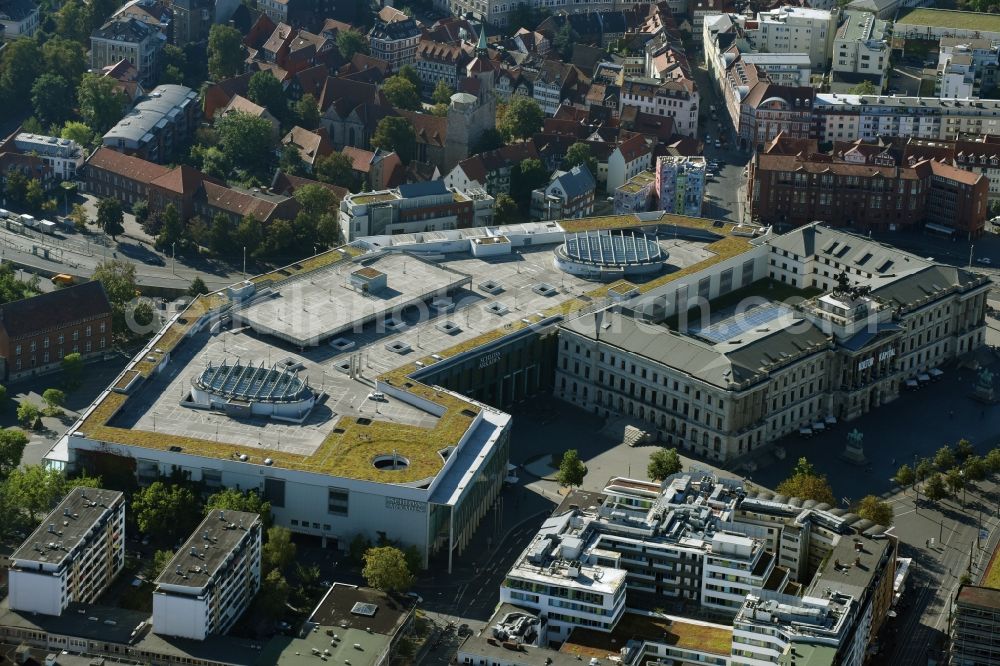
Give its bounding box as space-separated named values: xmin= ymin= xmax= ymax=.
xmin=153 ymin=509 xmax=261 ymax=641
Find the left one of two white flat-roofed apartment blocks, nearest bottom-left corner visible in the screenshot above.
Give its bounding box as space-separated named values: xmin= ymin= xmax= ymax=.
xmin=9 ymin=488 xmax=125 ymax=615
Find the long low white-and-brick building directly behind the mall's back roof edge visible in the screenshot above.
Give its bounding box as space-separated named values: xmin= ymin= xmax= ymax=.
xmin=338 ymin=180 xmax=493 ymax=241
